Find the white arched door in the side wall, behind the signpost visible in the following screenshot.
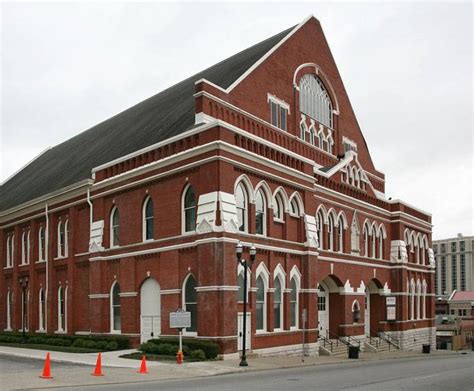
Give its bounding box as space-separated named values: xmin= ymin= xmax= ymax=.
xmin=140 ymin=278 xmax=161 ymax=343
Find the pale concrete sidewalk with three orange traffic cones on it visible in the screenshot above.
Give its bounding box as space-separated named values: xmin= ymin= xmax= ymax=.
xmin=0 ymin=347 xmax=466 ymax=390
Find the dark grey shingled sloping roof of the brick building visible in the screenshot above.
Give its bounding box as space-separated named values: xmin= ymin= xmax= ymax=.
xmin=0 ymin=27 xmax=293 ymax=211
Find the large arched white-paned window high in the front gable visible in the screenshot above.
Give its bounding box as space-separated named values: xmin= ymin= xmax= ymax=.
xmin=300 ymin=74 xmax=332 ymax=128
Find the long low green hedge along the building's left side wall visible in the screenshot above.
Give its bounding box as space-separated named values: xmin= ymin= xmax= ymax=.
xmin=0 ymin=333 xmax=130 ymax=351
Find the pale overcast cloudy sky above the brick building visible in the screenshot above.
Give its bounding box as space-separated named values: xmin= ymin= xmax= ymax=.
xmin=0 ymin=1 xmax=473 ymax=239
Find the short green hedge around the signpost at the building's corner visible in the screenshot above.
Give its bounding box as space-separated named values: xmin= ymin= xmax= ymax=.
xmin=139 ymin=338 xmax=219 ymax=360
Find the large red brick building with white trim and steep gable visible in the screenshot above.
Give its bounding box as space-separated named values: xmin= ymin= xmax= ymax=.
xmin=0 ymin=17 xmax=435 ymax=354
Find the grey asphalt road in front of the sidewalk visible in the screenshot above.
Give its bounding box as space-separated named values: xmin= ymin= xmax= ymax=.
xmin=34 ymin=353 xmax=474 ymax=391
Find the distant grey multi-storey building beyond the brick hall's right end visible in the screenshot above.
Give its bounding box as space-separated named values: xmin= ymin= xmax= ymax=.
xmin=433 ymin=234 xmax=474 ymax=298
